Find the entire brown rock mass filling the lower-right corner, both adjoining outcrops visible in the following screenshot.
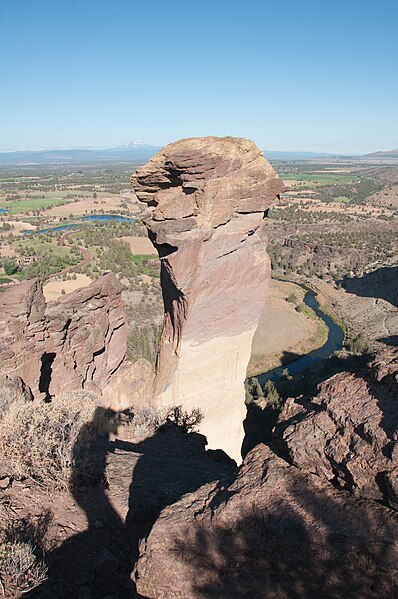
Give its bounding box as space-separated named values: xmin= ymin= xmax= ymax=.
xmin=134 ymin=349 xmax=398 ymax=599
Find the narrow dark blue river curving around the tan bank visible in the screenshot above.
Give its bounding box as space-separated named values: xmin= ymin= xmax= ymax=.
xmin=255 ymin=291 xmax=344 ymax=386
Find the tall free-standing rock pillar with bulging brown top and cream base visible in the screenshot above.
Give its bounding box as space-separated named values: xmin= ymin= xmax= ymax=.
xmin=131 ymin=137 xmax=283 ymax=461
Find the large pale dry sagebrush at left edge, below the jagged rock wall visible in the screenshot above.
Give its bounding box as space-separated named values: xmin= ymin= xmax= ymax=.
xmin=0 ymin=392 xmax=101 ymax=490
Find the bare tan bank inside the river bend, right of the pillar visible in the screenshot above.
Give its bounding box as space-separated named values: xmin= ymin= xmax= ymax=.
xmin=248 ymin=280 xmax=317 ymax=373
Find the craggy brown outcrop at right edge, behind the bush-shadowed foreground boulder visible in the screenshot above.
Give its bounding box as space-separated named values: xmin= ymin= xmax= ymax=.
xmin=275 ymin=348 xmax=398 ymax=509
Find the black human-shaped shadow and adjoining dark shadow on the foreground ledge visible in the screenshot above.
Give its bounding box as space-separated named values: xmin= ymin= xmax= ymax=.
xmin=27 ymin=408 xmax=236 ymax=599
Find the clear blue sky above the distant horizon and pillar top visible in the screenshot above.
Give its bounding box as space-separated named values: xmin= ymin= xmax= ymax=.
xmin=0 ymin=0 xmax=398 ymax=153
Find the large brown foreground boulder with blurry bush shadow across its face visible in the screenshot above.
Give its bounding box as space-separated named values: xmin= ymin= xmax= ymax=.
xmin=134 ymin=445 xmax=398 ymax=599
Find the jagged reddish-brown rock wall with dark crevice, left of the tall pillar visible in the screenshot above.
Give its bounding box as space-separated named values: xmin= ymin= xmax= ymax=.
xmin=0 ymin=274 xmax=126 ymax=398
